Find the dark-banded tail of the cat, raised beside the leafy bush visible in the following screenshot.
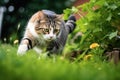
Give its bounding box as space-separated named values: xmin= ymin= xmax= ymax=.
xmin=65 ymin=15 xmax=76 ymax=33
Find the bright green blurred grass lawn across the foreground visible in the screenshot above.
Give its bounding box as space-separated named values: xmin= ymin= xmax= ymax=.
xmin=0 ymin=44 xmax=120 ymax=80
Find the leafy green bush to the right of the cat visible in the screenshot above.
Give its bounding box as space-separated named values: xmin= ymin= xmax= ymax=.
xmin=64 ymin=0 xmax=120 ymax=58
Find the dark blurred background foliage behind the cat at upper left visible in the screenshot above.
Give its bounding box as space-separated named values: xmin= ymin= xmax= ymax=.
xmin=0 ymin=0 xmax=75 ymax=43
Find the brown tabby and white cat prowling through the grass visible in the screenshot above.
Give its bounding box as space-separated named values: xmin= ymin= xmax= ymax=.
xmin=17 ymin=10 xmax=76 ymax=55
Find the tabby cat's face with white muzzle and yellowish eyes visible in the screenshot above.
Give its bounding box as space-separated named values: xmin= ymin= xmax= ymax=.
xmin=35 ymin=16 xmax=61 ymax=41
